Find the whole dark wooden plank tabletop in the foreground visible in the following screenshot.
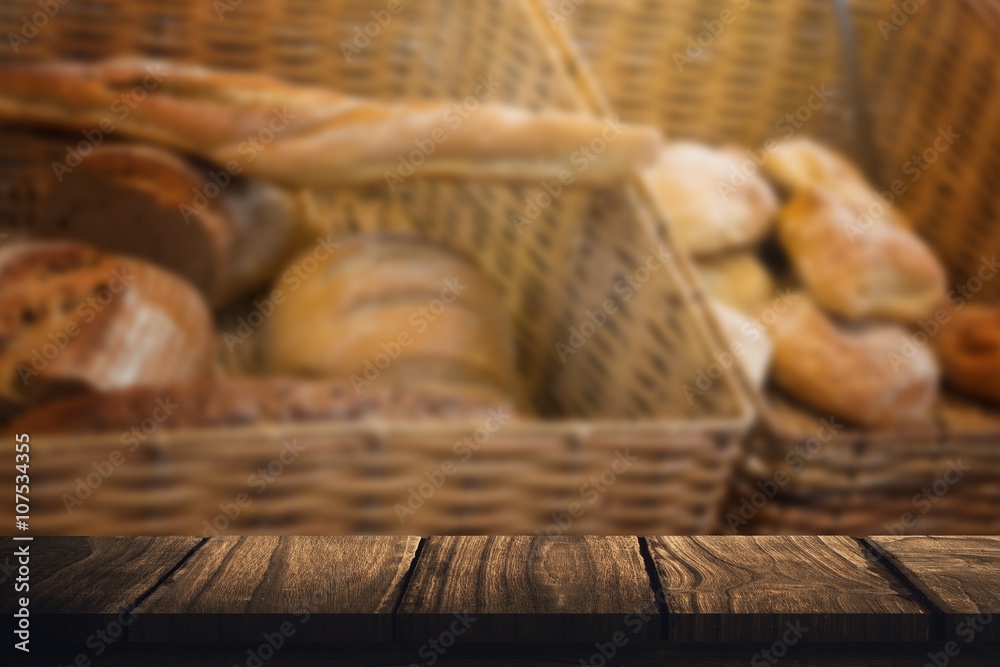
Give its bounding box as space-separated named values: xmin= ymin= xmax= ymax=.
xmin=0 ymin=536 xmax=1000 ymax=666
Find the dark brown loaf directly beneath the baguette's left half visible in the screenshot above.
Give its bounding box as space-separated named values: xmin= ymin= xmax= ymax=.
xmin=38 ymin=144 xmax=320 ymax=306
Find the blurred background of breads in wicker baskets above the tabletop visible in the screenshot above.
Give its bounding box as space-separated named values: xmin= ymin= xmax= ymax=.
xmin=0 ymin=0 xmax=1000 ymax=535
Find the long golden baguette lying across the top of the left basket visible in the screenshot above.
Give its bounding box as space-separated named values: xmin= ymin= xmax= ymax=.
xmin=0 ymin=58 xmax=661 ymax=186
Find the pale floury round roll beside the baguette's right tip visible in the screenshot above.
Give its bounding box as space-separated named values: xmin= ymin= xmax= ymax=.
xmin=645 ymin=142 xmax=778 ymax=256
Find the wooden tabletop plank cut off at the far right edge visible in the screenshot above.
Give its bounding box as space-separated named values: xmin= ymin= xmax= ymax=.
xmin=867 ymin=536 xmax=1000 ymax=645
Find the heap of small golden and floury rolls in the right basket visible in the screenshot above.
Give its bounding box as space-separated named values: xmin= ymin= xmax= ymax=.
xmin=645 ymin=139 xmax=1000 ymax=428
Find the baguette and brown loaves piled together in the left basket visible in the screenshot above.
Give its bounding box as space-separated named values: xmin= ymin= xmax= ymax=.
xmin=0 ymin=59 xmax=676 ymax=434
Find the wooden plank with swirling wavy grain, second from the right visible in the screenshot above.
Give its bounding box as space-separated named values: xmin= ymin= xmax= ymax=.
xmin=648 ymin=536 xmax=939 ymax=643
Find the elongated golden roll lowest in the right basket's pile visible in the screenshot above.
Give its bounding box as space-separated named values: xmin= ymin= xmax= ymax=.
xmin=769 ymin=295 xmax=939 ymax=428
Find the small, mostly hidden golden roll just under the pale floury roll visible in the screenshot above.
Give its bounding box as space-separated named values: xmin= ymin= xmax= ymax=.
xmin=695 ymin=252 xmax=777 ymax=315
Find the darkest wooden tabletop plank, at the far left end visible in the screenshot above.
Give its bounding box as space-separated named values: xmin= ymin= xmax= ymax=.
xmin=3 ymin=537 xmax=201 ymax=648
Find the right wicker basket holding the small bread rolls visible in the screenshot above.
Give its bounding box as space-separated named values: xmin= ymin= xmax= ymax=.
xmin=548 ymin=0 xmax=1000 ymax=534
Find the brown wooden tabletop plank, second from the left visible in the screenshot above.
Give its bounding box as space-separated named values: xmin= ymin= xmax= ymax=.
xmin=132 ymin=536 xmax=420 ymax=643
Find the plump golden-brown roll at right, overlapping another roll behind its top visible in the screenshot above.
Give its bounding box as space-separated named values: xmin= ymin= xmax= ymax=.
xmin=778 ymin=188 xmax=946 ymax=324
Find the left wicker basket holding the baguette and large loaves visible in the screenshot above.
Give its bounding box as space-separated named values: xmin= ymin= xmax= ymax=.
xmin=0 ymin=0 xmax=752 ymax=534
